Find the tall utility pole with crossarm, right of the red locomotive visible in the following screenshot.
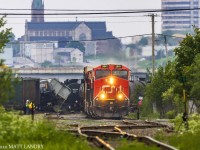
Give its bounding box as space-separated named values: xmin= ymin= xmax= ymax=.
xmin=148 ymin=14 xmax=157 ymax=76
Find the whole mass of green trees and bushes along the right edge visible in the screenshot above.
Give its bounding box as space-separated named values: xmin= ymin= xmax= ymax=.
xmin=143 ymin=28 xmax=200 ymax=117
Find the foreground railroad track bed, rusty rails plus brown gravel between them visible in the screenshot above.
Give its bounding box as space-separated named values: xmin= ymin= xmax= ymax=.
xmin=45 ymin=114 xmax=176 ymax=150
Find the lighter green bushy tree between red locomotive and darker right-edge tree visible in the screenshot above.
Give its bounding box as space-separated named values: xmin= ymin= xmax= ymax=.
xmin=142 ymin=62 xmax=186 ymax=117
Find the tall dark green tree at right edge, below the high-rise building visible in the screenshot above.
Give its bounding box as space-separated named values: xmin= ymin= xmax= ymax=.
xmin=174 ymin=27 xmax=200 ymax=106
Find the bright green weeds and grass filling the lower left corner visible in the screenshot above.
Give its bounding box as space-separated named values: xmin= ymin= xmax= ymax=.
xmin=0 ymin=107 xmax=92 ymax=150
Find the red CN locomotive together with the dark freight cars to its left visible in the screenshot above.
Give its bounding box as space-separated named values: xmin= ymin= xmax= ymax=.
xmin=5 ymin=64 xmax=146 ymax=118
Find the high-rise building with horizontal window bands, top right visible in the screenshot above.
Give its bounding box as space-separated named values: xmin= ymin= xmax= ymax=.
xmin=161 ymin=0 xmax=199 ymax=31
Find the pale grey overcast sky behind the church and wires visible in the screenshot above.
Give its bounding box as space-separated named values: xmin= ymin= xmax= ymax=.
xmin=0 ymin=0 xmax=161 ymax=38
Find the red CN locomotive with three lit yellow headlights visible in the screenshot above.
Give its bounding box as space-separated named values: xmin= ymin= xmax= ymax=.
xmin=83 ymin=64 xmax=130 ymax=118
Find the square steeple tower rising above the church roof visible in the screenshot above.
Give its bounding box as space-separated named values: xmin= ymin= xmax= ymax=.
xmin=31 ymin=0 xmax=44 ymax=22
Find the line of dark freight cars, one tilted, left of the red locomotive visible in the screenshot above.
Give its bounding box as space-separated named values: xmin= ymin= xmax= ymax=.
xmin=4 ymin=78 xmax=82 ymax=112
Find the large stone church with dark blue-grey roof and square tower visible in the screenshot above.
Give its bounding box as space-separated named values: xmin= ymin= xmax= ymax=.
xmin=23 ymin=0 xmax=115 ymax=55
